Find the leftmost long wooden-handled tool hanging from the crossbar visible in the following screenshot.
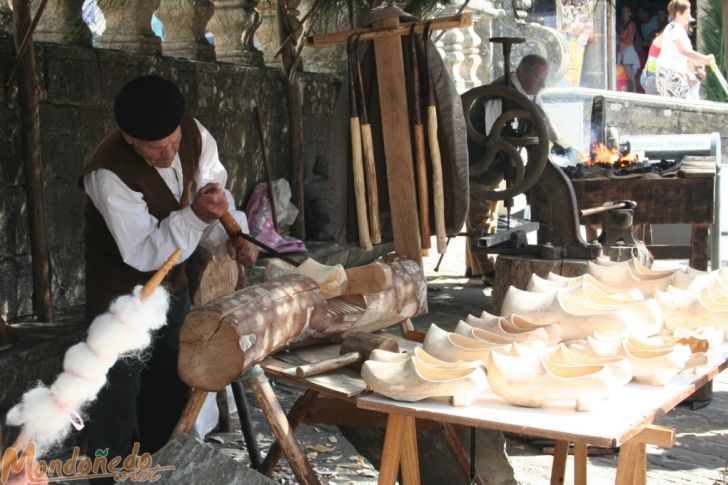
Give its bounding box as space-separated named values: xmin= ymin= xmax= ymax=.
xmin=346 ymin=37 xmax=372 ymax=251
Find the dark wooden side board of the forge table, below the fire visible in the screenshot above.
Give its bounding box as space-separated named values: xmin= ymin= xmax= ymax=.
xmin=571 ymin=176 xmax=715 ymax=224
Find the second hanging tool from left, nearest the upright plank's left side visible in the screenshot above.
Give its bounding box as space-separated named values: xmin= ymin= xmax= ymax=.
xmin=349 ymin=35 xmax=382 ymax=244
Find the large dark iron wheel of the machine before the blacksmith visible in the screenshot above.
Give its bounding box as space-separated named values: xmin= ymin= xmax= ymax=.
xmin=460 ymin=85 xmax=548 ymax=200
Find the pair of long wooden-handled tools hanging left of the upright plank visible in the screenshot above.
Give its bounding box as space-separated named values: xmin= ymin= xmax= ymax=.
xmin=346 ymin=34 xmax=382 ymax=250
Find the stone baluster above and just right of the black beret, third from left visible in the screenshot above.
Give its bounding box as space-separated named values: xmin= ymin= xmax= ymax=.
xmin=157 ymin=0 xmax=215 ymax=61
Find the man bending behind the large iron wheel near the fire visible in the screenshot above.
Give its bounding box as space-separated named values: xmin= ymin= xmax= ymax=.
xmin=465 ymin=54 xmax=578 ymax=283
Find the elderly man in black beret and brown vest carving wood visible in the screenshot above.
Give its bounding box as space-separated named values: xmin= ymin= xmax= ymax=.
xmin=79 ymin=76 xmax=258 ymax=481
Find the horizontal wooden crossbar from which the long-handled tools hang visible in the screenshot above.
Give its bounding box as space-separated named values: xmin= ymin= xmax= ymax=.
xmin=305 ymin=13 xmax=473 ymax=47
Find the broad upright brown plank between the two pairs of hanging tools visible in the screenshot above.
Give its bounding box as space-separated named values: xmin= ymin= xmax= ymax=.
xmin=374 ymin=17 xmax=422 ymax=266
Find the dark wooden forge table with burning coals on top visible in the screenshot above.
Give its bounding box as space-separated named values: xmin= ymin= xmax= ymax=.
xmin=571 ymin=161 xmax=715 ymax=270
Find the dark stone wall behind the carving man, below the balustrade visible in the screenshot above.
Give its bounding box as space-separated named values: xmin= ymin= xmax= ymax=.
xmin=0 ymin=38 xmax=338 ymax=318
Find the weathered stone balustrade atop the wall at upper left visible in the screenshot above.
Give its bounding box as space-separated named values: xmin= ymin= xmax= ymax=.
xmin=0 ymin=0 xmax=276 ymax=66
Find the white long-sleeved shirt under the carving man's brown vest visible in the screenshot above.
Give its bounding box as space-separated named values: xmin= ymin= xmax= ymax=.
xmin=83 ymin=116 xmax=248 ymax=271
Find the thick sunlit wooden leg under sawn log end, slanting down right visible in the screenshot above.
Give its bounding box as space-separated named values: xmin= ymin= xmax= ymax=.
xmin=243 ymin=365 xmax=319 ymax=485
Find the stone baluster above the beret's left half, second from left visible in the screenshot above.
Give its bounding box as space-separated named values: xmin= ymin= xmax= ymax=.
xmin=94 ymin=0 xmax=162 ymax=55
